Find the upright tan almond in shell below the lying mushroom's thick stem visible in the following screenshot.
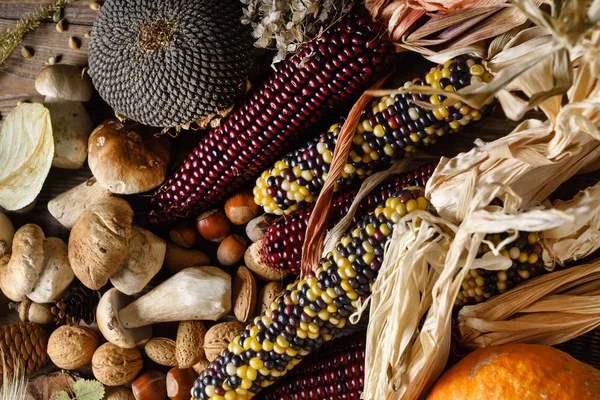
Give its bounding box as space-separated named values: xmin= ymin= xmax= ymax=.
xmin=175 ymin=321 xmax=206 ymax=369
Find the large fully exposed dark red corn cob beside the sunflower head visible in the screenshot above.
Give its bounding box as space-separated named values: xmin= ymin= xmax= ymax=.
xmin=150 ymin=11 xmax=393 ymax=222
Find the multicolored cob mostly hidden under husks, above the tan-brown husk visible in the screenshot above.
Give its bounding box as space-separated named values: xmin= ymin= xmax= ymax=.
xmin=456 ymin=232 xmax=547 ymax=306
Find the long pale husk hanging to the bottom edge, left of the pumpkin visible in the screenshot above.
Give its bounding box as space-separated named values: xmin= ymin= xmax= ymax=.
xmin=351 ymin=188 xmax=589 ymax=399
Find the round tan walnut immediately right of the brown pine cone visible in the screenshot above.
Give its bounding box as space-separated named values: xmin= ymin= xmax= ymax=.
xmin=48 ymin=326 xmax=98 ymax=369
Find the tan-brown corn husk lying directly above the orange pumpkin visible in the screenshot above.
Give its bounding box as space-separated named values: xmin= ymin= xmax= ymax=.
xmin=458 ymin=259 xmax=600 ymax=348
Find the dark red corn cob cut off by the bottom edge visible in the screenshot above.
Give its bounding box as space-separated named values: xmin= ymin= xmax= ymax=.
xmin=254 ymin=332 xmax=366 ymax=400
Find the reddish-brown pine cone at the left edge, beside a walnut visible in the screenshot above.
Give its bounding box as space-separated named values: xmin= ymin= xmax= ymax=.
xmin=0 ymin=322 xmax=48 ymax=385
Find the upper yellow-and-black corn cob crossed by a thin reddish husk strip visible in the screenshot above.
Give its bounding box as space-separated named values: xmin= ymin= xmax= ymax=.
xmin=254 ymin=56 xmax=494 ymax=214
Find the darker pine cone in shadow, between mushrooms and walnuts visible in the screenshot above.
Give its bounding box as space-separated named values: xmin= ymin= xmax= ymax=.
xmin=52 ymin=286 xmax=101 ymax=325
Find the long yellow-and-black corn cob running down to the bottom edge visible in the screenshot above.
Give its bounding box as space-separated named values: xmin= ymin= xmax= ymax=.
xmin=192 ymin=187 xmax=429 ymax=400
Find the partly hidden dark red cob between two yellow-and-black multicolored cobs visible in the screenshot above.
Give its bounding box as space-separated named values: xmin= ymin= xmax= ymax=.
xmin=248 ymin=163 xmax=437 ymax=274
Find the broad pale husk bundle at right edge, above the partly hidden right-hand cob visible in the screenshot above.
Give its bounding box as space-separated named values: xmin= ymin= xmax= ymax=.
xmin=426 ymin=55 xmax=600 ymax=223
